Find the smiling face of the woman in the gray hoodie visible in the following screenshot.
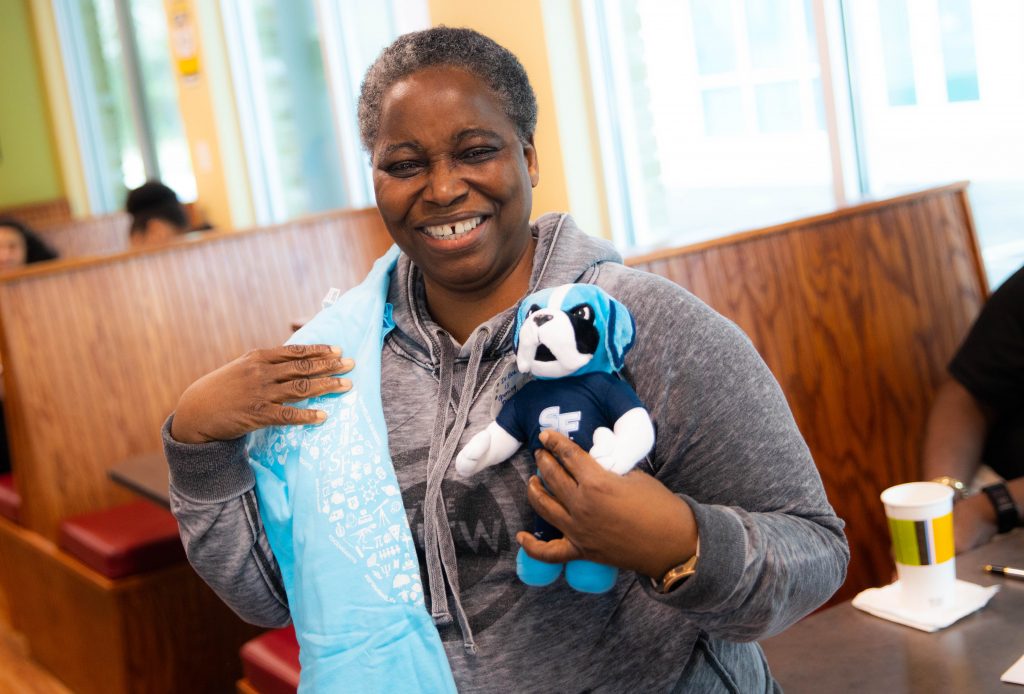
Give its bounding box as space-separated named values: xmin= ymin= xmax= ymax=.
xmin=373 ymin=67 xmax=539 ymax=295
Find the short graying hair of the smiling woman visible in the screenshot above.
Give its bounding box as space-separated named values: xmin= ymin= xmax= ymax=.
xmin=358 ymin=27 xmax=537 ymax=153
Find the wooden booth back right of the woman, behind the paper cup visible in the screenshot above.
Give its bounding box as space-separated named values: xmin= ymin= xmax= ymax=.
xmin=628 ymin=183 xmax=988 ymax=600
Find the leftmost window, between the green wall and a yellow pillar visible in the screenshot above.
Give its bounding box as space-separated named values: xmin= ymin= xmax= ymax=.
xmin=53 ymin=0 xmax=196 ymax=213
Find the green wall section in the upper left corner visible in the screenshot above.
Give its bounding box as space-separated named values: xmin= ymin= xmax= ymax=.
xmin=0 ymin=0 xmax=63 ymax=206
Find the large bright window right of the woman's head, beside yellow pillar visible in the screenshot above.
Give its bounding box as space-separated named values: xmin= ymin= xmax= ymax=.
xmin=591 ymin=0 xmax=833 ymax=247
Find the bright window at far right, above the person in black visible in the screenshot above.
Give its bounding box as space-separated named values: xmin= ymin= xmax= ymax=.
xmin=846 ymin=0 xmax=1024 ymax=288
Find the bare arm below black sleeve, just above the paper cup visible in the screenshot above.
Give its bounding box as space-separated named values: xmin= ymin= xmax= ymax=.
xmin=922 ymin=378 xmax=992 ymax=484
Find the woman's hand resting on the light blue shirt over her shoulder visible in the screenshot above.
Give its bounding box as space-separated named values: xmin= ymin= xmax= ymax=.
xmin=171 ymin=345 xmax=355 ymax=443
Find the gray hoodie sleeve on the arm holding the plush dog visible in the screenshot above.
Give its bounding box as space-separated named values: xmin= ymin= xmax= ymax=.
xmin=602 ymin=270 xmax=850 ymax=641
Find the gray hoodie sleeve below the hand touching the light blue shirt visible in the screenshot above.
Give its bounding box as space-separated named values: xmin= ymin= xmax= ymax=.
xmin=162 ymin=415 xmax=291 ymax=627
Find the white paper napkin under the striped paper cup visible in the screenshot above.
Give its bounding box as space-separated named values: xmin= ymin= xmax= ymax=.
xmin=853 ymin=580 xmax=999 ymax=632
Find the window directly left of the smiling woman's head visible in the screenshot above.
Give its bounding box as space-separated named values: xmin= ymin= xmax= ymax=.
xmin=221 ymin=0 xmax=428 ymax=223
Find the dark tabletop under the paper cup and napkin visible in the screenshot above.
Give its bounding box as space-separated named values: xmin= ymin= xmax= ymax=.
xmin=761 ymin=529 xmax=1024 ymax=694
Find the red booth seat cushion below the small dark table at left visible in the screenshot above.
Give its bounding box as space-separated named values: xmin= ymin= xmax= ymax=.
xmin=57 ymin=501 xmax=185 ymax=578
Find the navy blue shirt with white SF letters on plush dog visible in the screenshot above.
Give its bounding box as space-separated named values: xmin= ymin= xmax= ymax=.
xmin=498 ymin=374 xmax=643 ymax=450
